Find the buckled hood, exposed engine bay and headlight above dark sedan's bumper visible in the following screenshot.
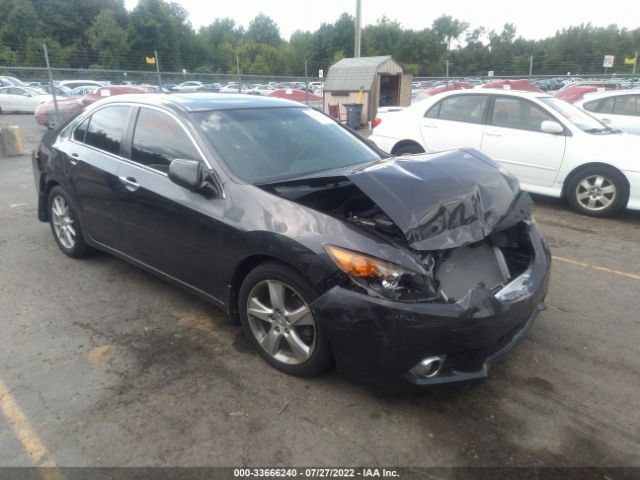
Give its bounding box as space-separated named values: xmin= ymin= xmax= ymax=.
xmin=263 ymin=152 xmax=544 ymax=304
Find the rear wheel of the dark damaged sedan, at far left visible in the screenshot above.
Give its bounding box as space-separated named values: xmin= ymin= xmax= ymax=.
xmin=47 ymin=186 xmax=89 ymax=258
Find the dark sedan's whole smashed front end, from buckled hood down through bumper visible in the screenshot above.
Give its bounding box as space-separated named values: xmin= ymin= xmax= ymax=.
xmin=263 ymin=151 xmax=550 ymax=390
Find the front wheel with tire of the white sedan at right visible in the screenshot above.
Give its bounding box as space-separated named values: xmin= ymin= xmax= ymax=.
xmin=566 ymin=166 xmax=629 ymax=217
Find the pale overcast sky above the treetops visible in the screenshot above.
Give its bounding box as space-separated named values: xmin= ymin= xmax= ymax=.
xmin=125 ymin=0 xmax=640 ymax=40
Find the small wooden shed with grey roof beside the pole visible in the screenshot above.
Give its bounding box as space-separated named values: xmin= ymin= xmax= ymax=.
xmin=324 ymin=55 xmax=413 ymax=125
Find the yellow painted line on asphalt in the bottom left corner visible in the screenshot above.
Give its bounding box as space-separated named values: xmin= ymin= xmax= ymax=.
xmin=0 ymin=378 xmax=63 ymax=480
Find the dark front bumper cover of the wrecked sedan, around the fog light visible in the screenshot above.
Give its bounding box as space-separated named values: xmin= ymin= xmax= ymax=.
xmin=312 ymin=225 xmax=551 ymax=392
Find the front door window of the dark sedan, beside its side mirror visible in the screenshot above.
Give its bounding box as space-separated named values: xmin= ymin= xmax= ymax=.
xmin=131 ymin=108 xmax=200 ymax=173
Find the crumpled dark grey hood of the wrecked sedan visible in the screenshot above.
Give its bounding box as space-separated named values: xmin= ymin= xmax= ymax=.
xmin=346 ymin=150 xmax=532 ymax=250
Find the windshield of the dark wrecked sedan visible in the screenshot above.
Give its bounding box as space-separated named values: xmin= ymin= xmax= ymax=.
xmin=193 ymin=107 xmax=381 ymax=184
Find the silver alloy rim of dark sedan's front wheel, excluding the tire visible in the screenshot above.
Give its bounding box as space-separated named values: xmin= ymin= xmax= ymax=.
xmin=247 ymin=280 xmax=317 ymax=365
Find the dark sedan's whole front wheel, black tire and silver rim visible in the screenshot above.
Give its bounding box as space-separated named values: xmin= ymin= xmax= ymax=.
xmin=238 ymin=262 xmax=332 ymax=377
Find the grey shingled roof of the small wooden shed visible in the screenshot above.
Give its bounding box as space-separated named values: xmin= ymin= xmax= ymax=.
xmin=324 ymin=55 xmax=400 ymax=92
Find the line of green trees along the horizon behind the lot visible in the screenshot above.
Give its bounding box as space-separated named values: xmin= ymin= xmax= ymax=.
xmin=0 ymin=0 xmax=640 ymax=76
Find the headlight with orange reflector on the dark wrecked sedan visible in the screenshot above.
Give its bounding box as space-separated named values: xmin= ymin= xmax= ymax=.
xmin=325 ymin=245 xmax=422 ymax=299
